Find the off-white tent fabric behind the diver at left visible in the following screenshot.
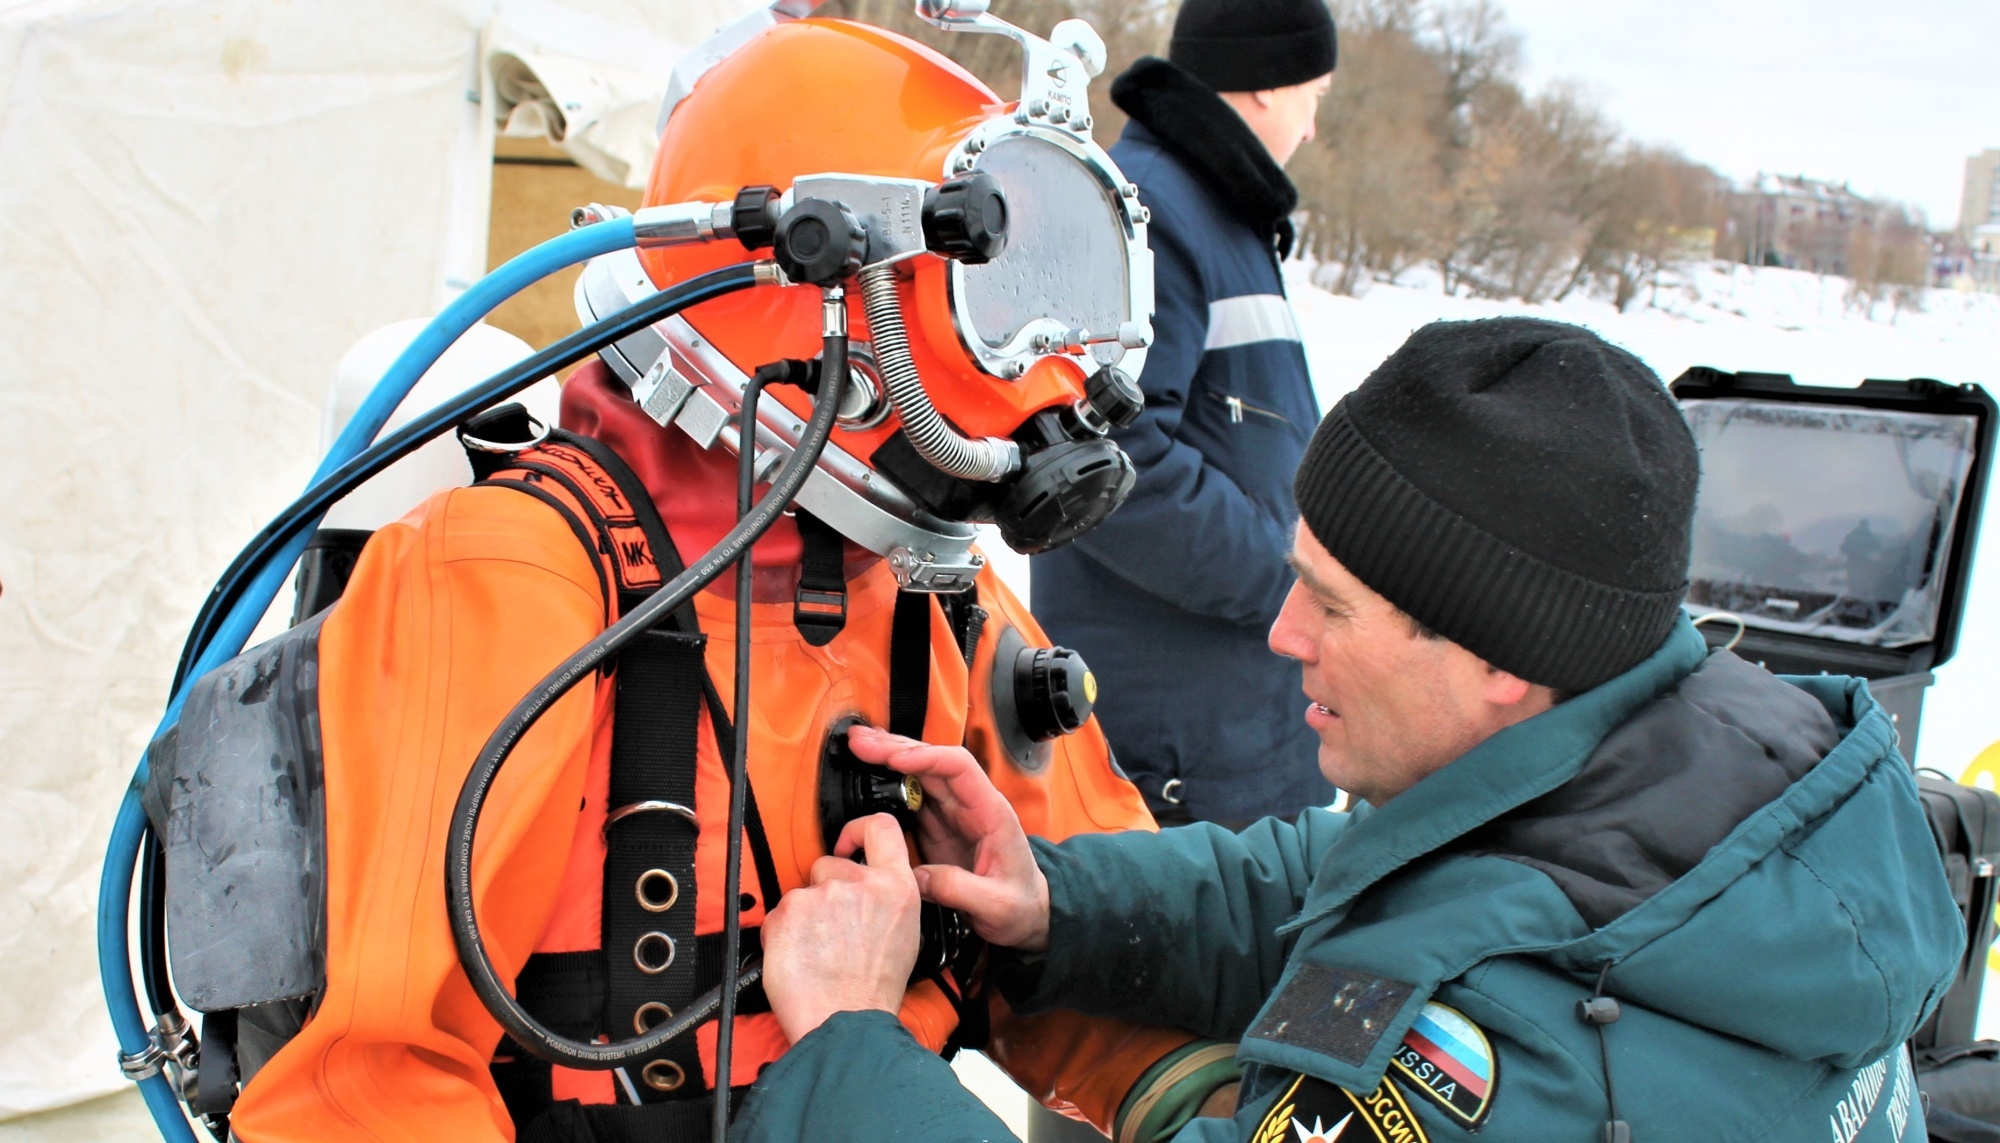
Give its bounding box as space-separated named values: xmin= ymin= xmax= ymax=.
xmin=0 ymin=0 xmax=750 ymax=1119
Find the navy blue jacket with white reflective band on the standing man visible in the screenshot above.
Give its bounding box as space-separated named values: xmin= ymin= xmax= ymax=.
xmin=1032 ymin=84 xmax=1334 ymax=821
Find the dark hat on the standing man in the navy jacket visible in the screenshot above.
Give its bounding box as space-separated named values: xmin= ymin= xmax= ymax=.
xmin=1166 ymin=0 xmax=1336 ymax=92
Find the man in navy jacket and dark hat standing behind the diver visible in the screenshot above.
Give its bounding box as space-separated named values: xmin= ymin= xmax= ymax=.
xmin=1034 ymin=0 xmax=1334 ymax=823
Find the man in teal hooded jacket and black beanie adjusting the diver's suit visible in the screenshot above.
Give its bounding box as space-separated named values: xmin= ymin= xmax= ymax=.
xmin=738 ymin=318 xmax=1964 ymax=1143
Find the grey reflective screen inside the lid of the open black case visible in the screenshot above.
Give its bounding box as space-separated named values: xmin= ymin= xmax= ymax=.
xmin=1682 ymin=400 xmax=1978 ymax=647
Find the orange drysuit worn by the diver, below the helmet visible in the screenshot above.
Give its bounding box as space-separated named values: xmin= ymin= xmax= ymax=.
xmin=232 ymin=364 xmax=1190 ymax=1143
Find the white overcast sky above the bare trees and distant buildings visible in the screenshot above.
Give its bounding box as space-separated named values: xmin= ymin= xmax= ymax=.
xmin=1498 ymin=0 xmax=2000 ymax=228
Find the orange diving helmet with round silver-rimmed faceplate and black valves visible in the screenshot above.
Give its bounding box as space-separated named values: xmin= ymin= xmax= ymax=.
xmin=576 ymin=0 xmax=1152 ymax=575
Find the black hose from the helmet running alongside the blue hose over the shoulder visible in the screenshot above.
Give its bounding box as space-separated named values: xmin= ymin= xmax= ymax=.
xmin=172 ymin=262 xmax=756 ymax=693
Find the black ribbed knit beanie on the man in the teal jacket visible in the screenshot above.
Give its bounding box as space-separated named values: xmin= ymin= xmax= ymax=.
xmin=1292 ymin=318 xmax=1700 ymax=693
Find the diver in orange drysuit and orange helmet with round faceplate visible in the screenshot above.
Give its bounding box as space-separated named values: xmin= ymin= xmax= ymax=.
xmin=199 ymin=6 xmax=1228 ymax=1143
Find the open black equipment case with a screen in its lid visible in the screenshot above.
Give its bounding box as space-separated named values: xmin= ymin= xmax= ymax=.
xmin=1670 ymin=366 xmax=2000 ymax=757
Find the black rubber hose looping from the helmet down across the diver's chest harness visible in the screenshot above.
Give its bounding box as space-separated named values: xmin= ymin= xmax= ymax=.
xmin=444 ymin=291 xmax=848 ymax=1063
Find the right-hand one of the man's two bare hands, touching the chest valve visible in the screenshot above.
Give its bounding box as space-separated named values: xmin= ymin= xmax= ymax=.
xmin=844 ymin=725 xmax=1048 ymax=953
